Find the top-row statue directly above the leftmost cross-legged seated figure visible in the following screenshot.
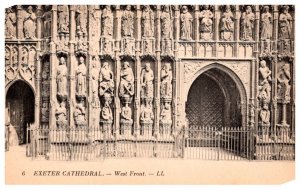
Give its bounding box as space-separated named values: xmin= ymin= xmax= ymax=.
xmin=101 ymin=5 xmax=113 ymax=36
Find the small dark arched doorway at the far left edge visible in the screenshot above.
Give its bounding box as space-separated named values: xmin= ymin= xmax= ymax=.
xmin=5 ymin=80 xmax=35 ymax=144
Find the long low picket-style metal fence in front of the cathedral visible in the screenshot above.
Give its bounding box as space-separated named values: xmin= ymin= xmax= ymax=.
xmin=26 ymin=126 xmax=295 ymax=160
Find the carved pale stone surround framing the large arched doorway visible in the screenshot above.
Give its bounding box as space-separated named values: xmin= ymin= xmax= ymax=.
xmin=181 ymin=62 xmax=250 ymax=126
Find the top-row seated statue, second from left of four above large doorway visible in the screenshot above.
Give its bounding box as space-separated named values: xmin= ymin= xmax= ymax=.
xmin=199 ymin=5 xmax=214 ymax=40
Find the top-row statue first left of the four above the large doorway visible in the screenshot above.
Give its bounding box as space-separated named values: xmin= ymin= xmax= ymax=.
xmin=160 ymin=6 xmax=173 ymax=38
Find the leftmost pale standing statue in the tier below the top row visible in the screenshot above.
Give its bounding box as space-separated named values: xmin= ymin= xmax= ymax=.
xmin=56 ymin=57 xmax=68 ymax=97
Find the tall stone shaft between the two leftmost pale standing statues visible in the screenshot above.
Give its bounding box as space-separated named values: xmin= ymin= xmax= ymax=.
xmin=68 ymin=5 xmax=77 ymax=128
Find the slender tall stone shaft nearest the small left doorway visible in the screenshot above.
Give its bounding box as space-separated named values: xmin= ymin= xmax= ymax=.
xmin=34 ymin=5 xmax=42 ymax=125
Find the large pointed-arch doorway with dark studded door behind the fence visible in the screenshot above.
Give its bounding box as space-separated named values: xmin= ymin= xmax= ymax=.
xmin=186 ymin=68 xmax=242 ymax=128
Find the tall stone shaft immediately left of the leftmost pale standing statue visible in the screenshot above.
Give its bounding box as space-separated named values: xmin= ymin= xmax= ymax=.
xmin=49 ymin=5 xmax=58 ymax=128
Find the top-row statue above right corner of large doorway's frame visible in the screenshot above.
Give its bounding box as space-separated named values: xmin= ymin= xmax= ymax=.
xmin=241 ymin=6 xmax=255 ymax=41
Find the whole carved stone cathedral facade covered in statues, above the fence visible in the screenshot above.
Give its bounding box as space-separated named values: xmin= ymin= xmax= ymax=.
xmin=5 ymin=5 xmax=295 ymax=142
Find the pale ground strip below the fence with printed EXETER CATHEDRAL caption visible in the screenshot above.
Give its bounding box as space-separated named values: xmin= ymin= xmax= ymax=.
xmin=5 ymin=147 xmax=295 ymax=184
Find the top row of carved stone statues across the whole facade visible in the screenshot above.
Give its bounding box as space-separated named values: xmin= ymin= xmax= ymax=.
xmin=5 ymin=5 xmax=293 ymax=41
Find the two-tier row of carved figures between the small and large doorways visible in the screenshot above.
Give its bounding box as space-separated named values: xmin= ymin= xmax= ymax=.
xmin=52 ymin=57 xmax=172 ymax=131
